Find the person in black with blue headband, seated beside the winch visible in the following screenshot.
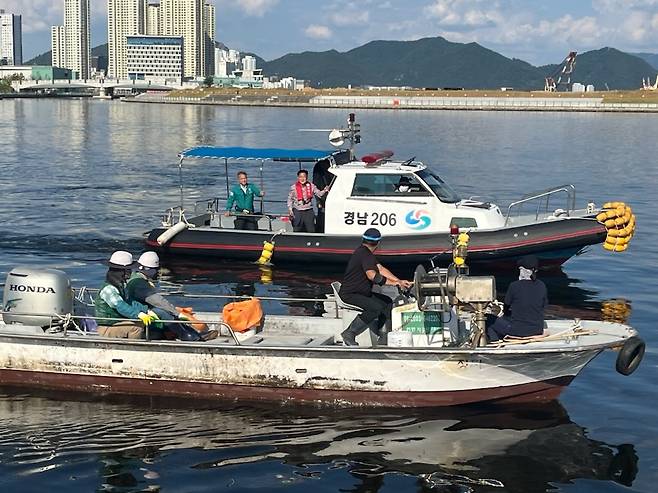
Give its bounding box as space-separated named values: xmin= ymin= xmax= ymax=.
xmin=338 ymin=228 xmax=412 ymax=346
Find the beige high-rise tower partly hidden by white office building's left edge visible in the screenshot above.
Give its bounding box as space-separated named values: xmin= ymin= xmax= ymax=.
xmin=107 ymin=0 xmax=148 ymax=79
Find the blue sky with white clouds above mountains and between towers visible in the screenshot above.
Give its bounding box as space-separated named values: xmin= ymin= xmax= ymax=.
xmin=7 ymin=0 xmax=658 ymax=65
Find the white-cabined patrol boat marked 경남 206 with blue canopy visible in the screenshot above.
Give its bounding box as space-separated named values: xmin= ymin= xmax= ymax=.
xmin=146 ymin=114 xmax=635 ymax=267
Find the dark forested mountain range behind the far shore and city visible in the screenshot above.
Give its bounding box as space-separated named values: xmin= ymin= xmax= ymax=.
xmin=26 ymin=37 xmax=658 ymax=90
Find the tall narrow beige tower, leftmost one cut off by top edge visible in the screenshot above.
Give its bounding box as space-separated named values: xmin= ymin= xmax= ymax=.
xmin=64 ymin=0 xmax=91 ymax=79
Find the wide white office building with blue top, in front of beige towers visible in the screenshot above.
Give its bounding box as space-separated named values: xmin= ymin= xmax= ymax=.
xmin=126 ymin=36 xmax=184 ymax=82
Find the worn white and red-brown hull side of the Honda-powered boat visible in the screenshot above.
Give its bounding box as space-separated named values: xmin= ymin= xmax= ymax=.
xmin=0 ymin=335 xmax=603 ymax=407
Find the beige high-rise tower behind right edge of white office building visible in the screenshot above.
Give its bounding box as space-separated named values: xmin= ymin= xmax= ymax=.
xmin=160 ymin=0 xmax=215 ymax=77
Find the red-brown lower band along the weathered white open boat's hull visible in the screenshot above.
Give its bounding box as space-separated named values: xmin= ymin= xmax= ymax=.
xmin=0 ymin=369 xmax=573 ymax=407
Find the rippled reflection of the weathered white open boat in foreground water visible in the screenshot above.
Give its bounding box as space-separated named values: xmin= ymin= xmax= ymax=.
xmin=0 ymin=393 xmax=638 ymax=493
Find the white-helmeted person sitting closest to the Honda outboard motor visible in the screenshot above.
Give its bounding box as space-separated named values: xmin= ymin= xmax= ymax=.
xmin=94 ymin=250 xmax=156 ymax=339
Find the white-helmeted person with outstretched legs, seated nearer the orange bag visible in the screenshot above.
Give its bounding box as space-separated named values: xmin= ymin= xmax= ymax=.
xmin=126 ymin=252 xmax=218 ymax=341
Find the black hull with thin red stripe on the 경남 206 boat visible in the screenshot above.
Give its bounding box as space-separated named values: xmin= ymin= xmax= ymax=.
xmin=146 ymin=218 xmax=606 ymax=266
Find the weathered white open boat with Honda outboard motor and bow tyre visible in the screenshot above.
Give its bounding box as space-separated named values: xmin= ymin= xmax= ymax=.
xmin=0 ymin=256 xmax=645 ymax=407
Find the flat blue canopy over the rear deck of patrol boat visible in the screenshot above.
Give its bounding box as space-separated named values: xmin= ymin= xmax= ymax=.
xmin=179 ymin=146 xmax=334 ymax=162
